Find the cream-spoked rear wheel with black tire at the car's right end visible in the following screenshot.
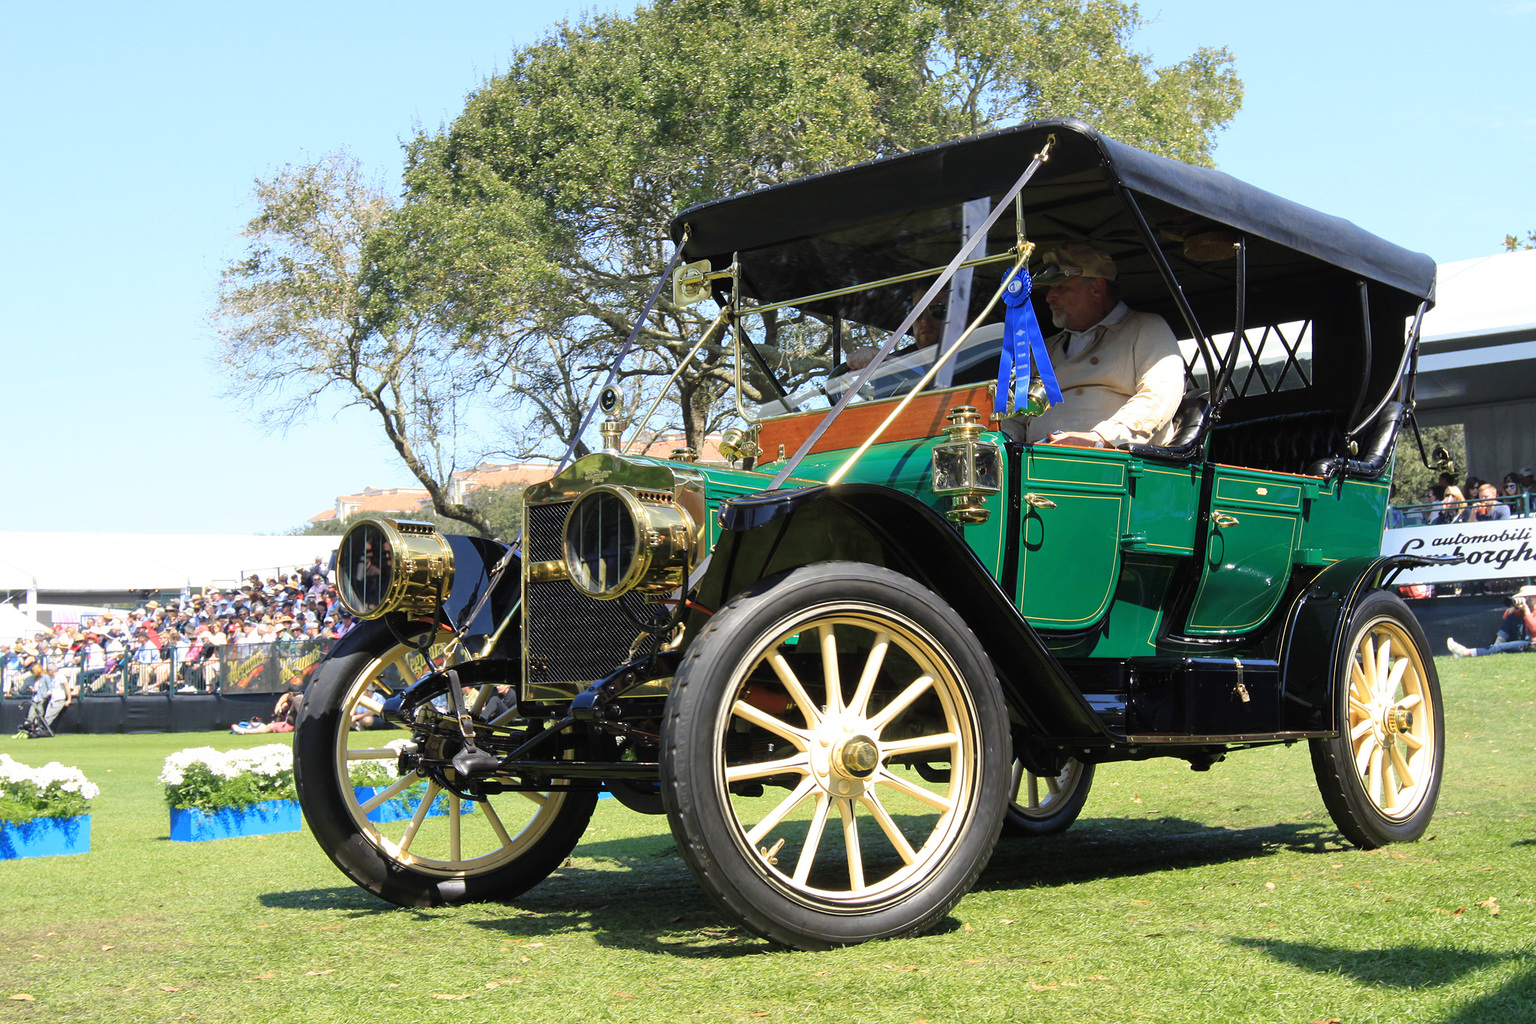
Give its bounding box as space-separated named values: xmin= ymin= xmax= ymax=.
xmin=1310 ymin=591 xmax=1445 ymax=849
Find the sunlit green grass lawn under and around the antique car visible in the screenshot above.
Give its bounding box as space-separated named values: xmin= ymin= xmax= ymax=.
xmin=0 ymin=656 xmax=1536 ymax=1024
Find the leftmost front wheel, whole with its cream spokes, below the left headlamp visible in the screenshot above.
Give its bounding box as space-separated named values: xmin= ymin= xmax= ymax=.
xmin=293 ymin=622 xmax=598 ymax=907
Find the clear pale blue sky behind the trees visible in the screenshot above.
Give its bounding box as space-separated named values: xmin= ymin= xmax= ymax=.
xmin=0 ymin=0 xmax=1536 ymax=533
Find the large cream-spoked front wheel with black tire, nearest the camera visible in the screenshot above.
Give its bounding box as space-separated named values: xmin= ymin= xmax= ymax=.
xmin=660 ymin=562 xmax=1011 ymax=949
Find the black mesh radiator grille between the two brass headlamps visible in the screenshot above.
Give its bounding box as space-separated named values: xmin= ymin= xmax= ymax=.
xmin=522 ymin=502 xmax=656 ymax=700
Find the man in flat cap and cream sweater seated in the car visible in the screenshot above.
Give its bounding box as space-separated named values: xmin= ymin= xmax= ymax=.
xmin=1026 ymin=243 xmax=1184 ymax=448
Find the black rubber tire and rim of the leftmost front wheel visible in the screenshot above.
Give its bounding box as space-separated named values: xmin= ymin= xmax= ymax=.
xmin=293 ymin=622 xmax=598 ymax=907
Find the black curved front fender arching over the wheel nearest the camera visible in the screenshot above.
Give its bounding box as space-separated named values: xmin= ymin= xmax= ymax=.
xmin=690 ymin=484 xmax=1115 ymax=743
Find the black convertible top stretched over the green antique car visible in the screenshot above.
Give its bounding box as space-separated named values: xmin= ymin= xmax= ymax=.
xmin=671 ymin=120 xmax=1435 ymax=330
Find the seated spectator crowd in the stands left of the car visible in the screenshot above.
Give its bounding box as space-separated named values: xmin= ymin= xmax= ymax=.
xmin=0 ymin=559 xmax=355 ymax=714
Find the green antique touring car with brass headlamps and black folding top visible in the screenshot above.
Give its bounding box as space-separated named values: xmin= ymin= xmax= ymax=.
xmin=295 ymin=120 xmax=1444 ymax=949
